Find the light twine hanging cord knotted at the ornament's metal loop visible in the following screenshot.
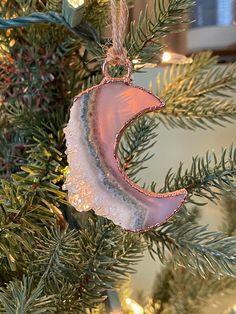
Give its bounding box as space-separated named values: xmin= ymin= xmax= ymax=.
xmin=106 ymin=0 xmax=129 ymax=65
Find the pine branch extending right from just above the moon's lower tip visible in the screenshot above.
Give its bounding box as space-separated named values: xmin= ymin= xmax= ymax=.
xmin=161 ymin=145 xmax=236 ymax=203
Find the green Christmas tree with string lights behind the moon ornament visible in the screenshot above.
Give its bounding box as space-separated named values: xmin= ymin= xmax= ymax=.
xmin=0 ymin=0 xmax=236 ymax=314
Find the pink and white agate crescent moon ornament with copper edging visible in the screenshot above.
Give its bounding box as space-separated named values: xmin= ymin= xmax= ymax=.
xmin=64 ymin=63 xmax=187 ymax=231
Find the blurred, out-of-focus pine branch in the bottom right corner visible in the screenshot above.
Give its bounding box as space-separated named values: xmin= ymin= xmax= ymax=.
xmin=153 ymin=263 xmax=235 ymax=314
